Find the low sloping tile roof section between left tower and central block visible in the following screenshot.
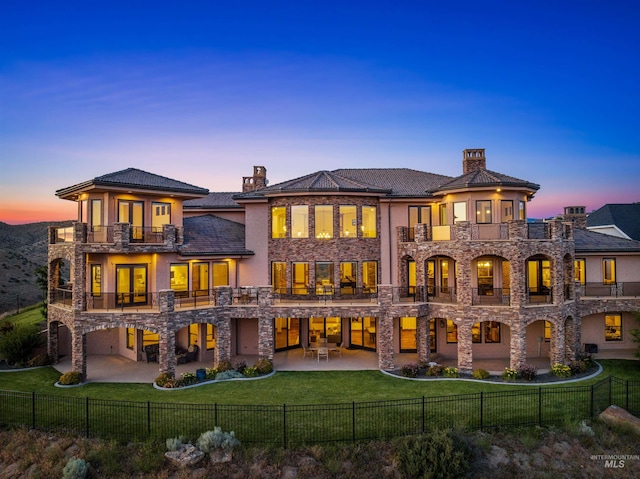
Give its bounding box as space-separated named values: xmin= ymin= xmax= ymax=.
xmin=180 ymin=215 xmax=254 ymax=256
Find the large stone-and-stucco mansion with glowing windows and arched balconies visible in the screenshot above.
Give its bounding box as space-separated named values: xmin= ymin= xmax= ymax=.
xmin=48 ymin=149 xmax=640 ymax=374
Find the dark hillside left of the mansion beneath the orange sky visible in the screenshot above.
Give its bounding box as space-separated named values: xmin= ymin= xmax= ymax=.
xmin=0 ymin=221 xmax=71 ymax=314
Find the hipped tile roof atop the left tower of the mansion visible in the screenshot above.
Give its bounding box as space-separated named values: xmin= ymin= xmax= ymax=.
xmin=56 ymin=168 xmax=209 ymax=196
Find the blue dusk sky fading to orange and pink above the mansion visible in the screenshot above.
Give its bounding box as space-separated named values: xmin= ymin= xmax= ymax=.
xmin=0 ymin=0 xmax=640 ymax=224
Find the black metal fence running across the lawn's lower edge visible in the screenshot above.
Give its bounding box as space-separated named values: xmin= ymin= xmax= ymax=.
xmin=0 ymin=377 xmax=640 ymax=448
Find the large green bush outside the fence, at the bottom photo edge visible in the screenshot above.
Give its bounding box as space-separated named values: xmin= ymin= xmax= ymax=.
xmin=398 ymin=430 xmax=474 ymax=479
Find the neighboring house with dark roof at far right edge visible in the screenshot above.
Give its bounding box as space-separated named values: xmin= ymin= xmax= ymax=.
xmin=587 ymin=203 xmax=640 ymax=241
